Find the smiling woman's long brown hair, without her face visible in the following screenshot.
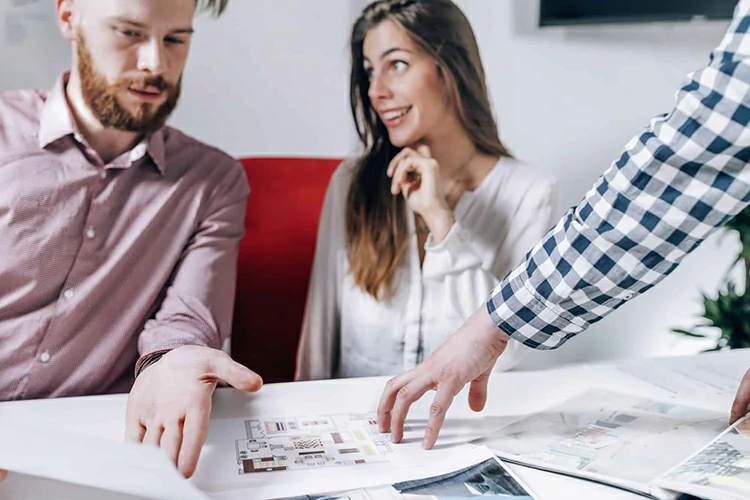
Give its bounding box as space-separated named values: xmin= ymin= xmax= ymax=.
xmin=346 ymin=0 xmax=511 ymax=299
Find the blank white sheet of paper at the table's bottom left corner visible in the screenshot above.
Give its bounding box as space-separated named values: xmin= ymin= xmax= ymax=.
xmin=0 ymin=416 xmax=208 ymax=500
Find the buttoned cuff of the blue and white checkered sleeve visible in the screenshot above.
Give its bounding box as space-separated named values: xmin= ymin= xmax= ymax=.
xmin=487 ymin=263 xmax=588 ymax=350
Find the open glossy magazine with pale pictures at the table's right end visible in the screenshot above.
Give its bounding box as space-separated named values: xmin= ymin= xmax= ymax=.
xmin=477 ymin=389 xmax=750 ymax=500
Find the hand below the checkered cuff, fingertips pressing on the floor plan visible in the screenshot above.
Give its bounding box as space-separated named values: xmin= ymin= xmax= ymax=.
xmin=378 ymin=306 xmax=510 ymax=450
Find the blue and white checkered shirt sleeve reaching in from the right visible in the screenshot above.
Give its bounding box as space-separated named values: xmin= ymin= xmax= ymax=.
xmin=487 ymin=0 xmax=750 ymax=349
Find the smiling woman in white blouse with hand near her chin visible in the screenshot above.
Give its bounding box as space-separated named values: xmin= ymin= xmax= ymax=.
xmin=297 ymin=0 xmax=556 ymax=379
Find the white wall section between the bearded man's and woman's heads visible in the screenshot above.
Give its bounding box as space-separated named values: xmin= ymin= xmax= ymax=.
xmin=172 ymin=0 xmax=353 ymax=156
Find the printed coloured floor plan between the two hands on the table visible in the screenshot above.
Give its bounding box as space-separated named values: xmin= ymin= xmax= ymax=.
xmin=234 ymin=414 xmax=400 ymax=474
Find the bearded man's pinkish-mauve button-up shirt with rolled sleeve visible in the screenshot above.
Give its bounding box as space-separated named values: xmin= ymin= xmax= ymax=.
xmin=0 ymin=75 xmax=249 ymax=401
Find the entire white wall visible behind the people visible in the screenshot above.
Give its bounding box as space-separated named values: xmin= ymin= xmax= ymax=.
xmin=0 ymin=0 xmax=748 ymax=366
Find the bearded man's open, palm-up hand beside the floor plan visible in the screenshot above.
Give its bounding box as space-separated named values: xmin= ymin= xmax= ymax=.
xmin=125 ymin=346 xmax=263 ymax=477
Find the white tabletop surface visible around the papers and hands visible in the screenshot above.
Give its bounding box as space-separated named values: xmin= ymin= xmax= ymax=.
xmin=0 ymin=350 xmax=750 ymax=500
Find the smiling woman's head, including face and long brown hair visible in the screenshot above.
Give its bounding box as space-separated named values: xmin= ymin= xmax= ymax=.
xmin=347 ymin=0 xmax=511 ymax=296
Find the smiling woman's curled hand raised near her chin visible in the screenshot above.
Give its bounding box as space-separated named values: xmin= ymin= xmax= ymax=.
xmin=387 ymin=146 xmax=454 ymax=244
